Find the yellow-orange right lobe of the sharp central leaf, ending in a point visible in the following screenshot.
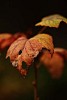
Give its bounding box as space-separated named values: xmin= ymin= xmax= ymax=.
xmin=30 ymin=33 xmax=54 ymax=54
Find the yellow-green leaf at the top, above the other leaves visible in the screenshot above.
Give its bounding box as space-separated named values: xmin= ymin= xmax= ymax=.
xmin=35 ymin=14 xmax=67 ymax=28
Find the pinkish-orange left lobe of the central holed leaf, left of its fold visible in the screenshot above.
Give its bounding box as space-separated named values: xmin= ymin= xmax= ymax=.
xmin=6 ymin=36 xmax=27 ymax=61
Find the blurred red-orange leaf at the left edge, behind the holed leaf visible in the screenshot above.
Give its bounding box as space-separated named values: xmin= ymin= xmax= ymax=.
xmin=0 ymin=33 xmax=23 ymax=51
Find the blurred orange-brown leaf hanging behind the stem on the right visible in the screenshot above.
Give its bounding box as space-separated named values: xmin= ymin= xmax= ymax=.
xmin=40 ymin=48 xmax=67 ymax=78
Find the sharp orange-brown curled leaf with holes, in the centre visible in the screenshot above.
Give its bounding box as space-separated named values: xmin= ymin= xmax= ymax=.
xmin=6 ymin=34 xmax=53 ymax=75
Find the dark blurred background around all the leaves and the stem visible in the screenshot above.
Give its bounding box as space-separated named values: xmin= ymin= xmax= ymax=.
xmin=0 ymin=0 xmax=67 ymax=100
